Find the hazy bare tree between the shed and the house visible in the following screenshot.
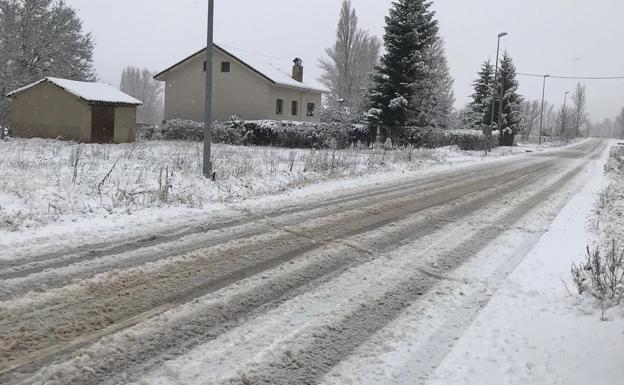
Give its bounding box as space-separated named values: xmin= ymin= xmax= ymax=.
xmin=120 ymin=67 xmax=164 ymax=124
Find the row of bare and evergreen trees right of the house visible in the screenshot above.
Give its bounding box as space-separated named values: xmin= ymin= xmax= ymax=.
xmin=320 ymin=0 xmax=624 ymax=146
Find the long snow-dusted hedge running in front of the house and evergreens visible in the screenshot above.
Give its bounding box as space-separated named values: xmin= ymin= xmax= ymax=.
xmin=156 ymin=120 xmax=498 ymax=150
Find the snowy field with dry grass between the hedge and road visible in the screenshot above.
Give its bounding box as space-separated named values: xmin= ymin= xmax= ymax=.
xmin=0 ymin=139 xmax=461 ymax=231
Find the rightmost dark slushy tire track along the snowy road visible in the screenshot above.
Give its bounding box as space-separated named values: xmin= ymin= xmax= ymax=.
xmin=222 ymin=152 xmax=600 ymax=385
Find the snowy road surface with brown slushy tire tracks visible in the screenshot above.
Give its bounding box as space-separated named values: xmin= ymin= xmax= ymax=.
xmin=0 ymin=140 xmax=606 ymax=384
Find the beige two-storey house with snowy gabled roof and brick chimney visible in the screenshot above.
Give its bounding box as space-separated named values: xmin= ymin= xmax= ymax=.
xmin=154 ymin=44 xmax=328 ymax=122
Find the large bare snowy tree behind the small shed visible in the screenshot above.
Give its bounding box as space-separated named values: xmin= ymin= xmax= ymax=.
xmin=0 ymin=0 xmax=95 ymax=125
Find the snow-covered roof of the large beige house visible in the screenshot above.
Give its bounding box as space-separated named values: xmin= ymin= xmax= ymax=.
xmin=154 ymin=44 xmax=329 ymax=93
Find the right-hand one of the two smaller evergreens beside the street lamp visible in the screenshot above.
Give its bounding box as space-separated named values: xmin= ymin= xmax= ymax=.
xmin=494 ymin=52 xmax=523 ymax=146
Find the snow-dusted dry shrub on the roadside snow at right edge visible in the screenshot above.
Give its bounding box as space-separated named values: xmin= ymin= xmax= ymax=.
xmin=571 ymin=240 xmax=624 ymax=309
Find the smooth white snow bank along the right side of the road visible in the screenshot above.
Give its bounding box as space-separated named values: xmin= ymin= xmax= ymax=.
xmin=428 ymin=140 xmax=624 ymax=385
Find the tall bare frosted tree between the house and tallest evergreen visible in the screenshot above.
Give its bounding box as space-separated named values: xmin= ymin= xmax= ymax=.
xmin=319 ymin=0 xmax=381 ymax=121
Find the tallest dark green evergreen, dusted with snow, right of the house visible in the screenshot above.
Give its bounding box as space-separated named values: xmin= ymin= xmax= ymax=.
xmin=368 ymin=0 xmax=438 ymax=139
